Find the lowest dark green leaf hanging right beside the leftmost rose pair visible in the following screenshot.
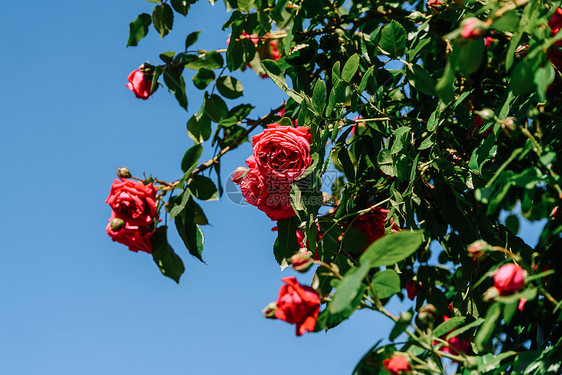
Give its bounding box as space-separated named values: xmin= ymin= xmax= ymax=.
xmin=152 ymin=226 xmax=185 ymax=284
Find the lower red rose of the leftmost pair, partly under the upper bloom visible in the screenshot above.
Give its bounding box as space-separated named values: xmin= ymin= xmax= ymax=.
xmin=105 ymin=212 xmax=153 ymax=254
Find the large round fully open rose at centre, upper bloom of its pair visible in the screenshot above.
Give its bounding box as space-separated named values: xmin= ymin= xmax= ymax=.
xmin=252 ymin=124 xmax=312 ymax=183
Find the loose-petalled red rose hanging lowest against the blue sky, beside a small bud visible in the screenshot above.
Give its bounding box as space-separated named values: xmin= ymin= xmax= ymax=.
xmin=275 ymin=277 xmax=320 ymax=336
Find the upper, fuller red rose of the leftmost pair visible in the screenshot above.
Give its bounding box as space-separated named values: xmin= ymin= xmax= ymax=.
xmin=105 ymin=179 xmax=158 ymax=226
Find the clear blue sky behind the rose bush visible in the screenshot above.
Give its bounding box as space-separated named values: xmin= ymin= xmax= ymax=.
xmin=0 ymin=0 xmax=537 ymax=375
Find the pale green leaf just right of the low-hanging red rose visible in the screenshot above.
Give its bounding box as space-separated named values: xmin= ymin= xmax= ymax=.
xmin=327 ymin=260 xmax=371 ymax=314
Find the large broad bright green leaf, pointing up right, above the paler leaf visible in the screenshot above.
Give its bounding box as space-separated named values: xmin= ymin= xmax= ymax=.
xmin=359 ymin=230 xmax=423 ymax=267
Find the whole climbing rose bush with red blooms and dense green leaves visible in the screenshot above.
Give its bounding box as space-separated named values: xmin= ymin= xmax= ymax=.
xmin=106 ymin=0 xmax=562 ymax=374
